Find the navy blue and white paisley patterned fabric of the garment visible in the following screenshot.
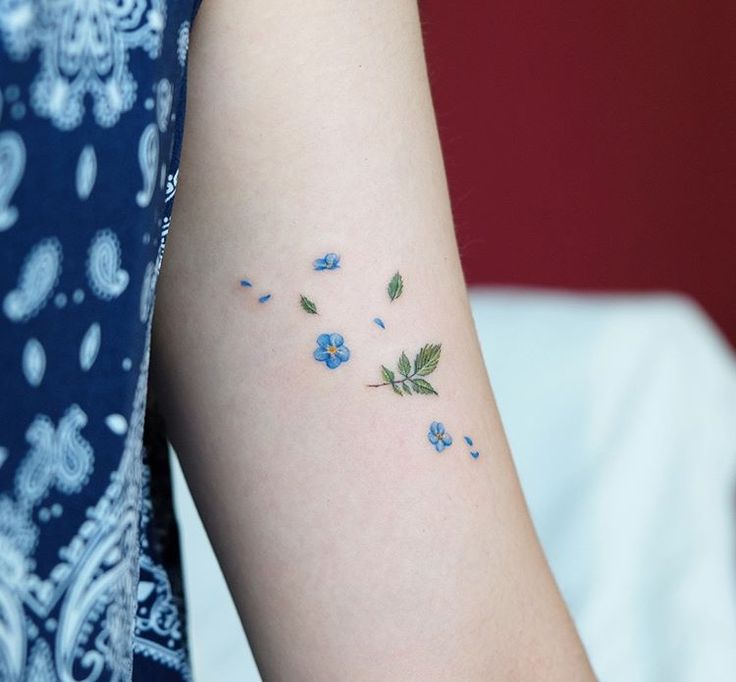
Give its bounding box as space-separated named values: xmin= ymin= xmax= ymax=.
xmin=0 ymin=0 xmax=198 ymax=682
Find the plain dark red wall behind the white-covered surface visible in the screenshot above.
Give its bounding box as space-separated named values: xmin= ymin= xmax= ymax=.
xmin=420 ymin=0 xmax=736 ymax=342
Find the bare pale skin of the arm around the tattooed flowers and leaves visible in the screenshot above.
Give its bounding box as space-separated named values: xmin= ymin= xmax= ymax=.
xmin=151 ymin=0 xmax=594 ymax=682
